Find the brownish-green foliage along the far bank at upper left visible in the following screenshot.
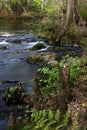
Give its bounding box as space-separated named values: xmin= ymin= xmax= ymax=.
xmin=0 ymin=0 xmax=41 ymax=17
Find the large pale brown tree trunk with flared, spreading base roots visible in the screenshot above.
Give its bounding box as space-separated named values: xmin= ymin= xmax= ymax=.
xmin=58 ymin=0 xmax=86 ymax=41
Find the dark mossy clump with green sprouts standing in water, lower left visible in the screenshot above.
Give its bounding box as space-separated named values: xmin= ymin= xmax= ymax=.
xmin=3 ymin=82 xmax=26 ymax=105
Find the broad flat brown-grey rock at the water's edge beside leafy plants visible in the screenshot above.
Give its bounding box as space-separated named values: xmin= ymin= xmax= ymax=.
xmin=27 ymin=52 xmax=58 ymax=66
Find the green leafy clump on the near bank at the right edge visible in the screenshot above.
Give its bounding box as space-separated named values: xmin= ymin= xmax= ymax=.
xmin=60 ymin=55 xmax=87 ymax=84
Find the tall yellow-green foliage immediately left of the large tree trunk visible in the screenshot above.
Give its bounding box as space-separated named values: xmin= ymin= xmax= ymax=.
xmin=42 ymin=0 xmax=66 ymax=42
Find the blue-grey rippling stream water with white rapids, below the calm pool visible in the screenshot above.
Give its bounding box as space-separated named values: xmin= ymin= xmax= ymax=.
xmin=0 ymin=32 xmax=46 ymax=91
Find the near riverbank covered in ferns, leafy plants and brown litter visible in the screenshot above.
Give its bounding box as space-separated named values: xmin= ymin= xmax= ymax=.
xmin=6 ymin=54 xmax=87 ymax=130
